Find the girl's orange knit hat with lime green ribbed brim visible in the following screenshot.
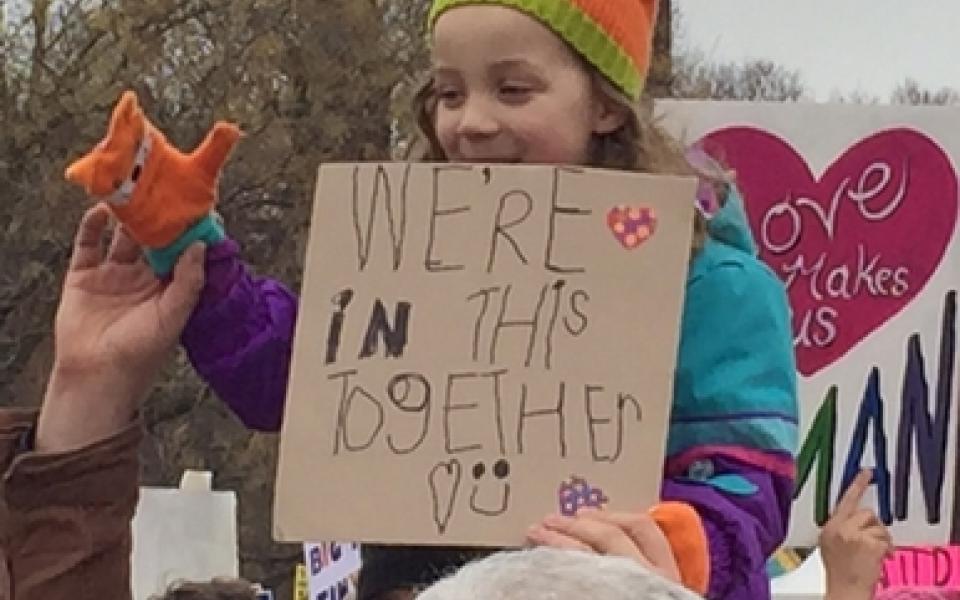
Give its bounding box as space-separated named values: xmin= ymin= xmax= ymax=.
xmin=428 ymin=0 xmax=657 ymax=100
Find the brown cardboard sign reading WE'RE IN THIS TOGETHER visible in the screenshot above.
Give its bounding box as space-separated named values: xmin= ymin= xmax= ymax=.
xmin=274 ymin=163 xmax=696 ymax=546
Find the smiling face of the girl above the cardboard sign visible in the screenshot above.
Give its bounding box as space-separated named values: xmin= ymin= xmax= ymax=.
xmin=432 ymin=5 xmax=625 ymax=164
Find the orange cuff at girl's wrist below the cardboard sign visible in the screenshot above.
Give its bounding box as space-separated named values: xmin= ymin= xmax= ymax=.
xmin=650 ymin=502 xmax=710 ymax=596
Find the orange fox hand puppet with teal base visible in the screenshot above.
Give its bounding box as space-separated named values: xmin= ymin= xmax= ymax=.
xmin=66 ymin=91 xmax=240 ymax=277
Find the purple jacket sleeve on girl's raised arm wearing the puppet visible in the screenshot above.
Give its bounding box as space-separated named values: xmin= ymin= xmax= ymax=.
xmin=181 ymin=239 xmax=297 ymax=431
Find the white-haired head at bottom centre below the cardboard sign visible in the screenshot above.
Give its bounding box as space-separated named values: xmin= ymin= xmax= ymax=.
xmin=417 ymin=548 xmax=699 ymax=600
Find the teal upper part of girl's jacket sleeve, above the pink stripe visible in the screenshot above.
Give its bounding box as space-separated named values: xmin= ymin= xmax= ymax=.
xmin=667 ymin=246 xmax=798 ymax=461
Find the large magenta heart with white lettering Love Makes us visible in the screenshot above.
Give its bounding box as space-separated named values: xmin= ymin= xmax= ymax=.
xmin=701 ymin=127 xmax=958 ymax=376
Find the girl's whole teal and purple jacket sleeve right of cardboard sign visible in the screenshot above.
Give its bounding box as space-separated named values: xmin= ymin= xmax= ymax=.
xmin=663 ymin=240 xmax=798 ymax=600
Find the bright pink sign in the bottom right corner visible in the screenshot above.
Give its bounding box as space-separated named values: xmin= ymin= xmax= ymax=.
xmin=880 ymin=546 xmax=960 ymax=590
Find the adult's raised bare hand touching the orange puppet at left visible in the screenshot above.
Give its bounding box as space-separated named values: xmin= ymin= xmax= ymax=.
xmin=36 ymin=205 xmax=204 ymax=452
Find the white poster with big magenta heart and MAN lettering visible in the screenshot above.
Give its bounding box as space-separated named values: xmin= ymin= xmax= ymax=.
xmin=659 ymin=103 xmax=960 ymax=546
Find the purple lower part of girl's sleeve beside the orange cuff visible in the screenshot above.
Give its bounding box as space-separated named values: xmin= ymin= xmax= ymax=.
xmin=662 ymin=457 xmax=793 ymax=600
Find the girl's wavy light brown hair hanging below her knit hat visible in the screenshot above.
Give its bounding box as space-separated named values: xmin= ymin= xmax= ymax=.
xmin=408 ymin=67 xmax=731 ymax=253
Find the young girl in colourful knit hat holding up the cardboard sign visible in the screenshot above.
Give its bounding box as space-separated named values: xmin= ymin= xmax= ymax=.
xmin=176 ymin=0 xmax=797 ymax=600
